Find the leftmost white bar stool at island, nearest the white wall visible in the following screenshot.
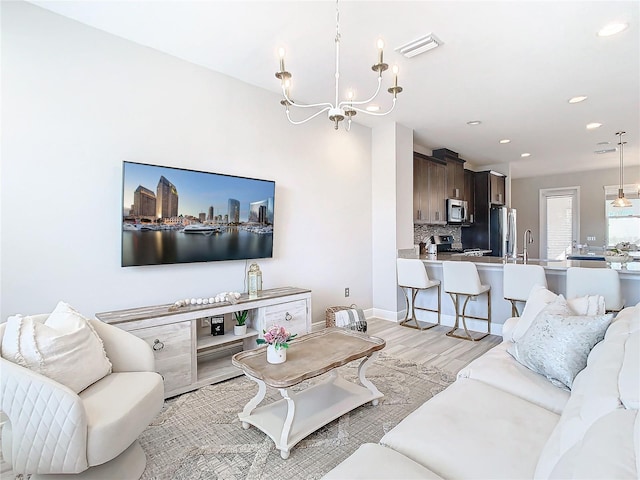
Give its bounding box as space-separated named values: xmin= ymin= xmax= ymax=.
xmin=397 ymin=258 xmax=441 ymax=330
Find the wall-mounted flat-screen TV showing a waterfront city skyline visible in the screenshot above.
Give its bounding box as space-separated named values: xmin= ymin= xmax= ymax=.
xmin=122 ymin=162 xmax=275 ymax=267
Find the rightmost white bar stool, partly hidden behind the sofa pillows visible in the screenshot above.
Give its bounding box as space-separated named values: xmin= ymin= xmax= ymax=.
xmin=567 ymin=267 xmax=624 ymax=312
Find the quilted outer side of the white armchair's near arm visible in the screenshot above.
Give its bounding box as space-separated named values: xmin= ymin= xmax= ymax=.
xmin=0 ymin=357 xmax=88 ymax=473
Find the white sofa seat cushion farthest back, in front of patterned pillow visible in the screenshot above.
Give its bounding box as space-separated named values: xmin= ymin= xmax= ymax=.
xmin=458 ymin=342 xmax=570 ymax=415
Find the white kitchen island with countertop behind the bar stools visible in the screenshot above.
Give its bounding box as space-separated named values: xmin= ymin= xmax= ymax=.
xmin=399 ymin=249 xmax=640 ymax=335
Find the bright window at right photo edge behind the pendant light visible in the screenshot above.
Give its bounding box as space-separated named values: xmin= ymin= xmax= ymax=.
xmin=604 ymin=185 xmax=640 ymax=247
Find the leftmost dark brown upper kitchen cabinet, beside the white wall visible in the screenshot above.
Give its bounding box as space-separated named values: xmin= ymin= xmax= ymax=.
xmin=413 ymin=152 xmax=447 ymax=225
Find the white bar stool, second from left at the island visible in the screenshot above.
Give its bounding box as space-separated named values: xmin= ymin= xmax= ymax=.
xmin=442 ymin=261 xmax=491 ymax=342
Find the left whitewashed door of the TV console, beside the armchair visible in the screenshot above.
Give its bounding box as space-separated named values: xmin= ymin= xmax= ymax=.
xmin=129 ymin=321 xmax=192 ymax=396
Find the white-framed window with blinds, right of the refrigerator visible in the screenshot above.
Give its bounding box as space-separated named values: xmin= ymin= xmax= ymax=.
xmin=540 ymin=187 xmax=580 ymax=260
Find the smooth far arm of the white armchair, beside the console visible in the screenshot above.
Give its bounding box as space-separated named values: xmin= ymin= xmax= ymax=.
xmin=89 ymin=318 xmax=155 ymax=372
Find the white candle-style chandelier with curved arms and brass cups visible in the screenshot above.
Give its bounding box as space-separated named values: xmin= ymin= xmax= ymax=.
xmin=276 ymin=0 xmax=402 ymax=131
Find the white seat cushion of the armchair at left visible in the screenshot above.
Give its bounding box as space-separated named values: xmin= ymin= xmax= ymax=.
xmin=79 ymin=372 xmax=164 ymax=466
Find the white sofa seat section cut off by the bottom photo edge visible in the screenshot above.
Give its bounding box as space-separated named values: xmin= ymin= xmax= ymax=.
xmin=322 ymin=443 xmax=441 ymax=480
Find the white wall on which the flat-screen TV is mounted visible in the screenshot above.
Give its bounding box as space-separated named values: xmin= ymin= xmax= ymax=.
xmin=0 ymin=2 xmax=372 ymax=321
